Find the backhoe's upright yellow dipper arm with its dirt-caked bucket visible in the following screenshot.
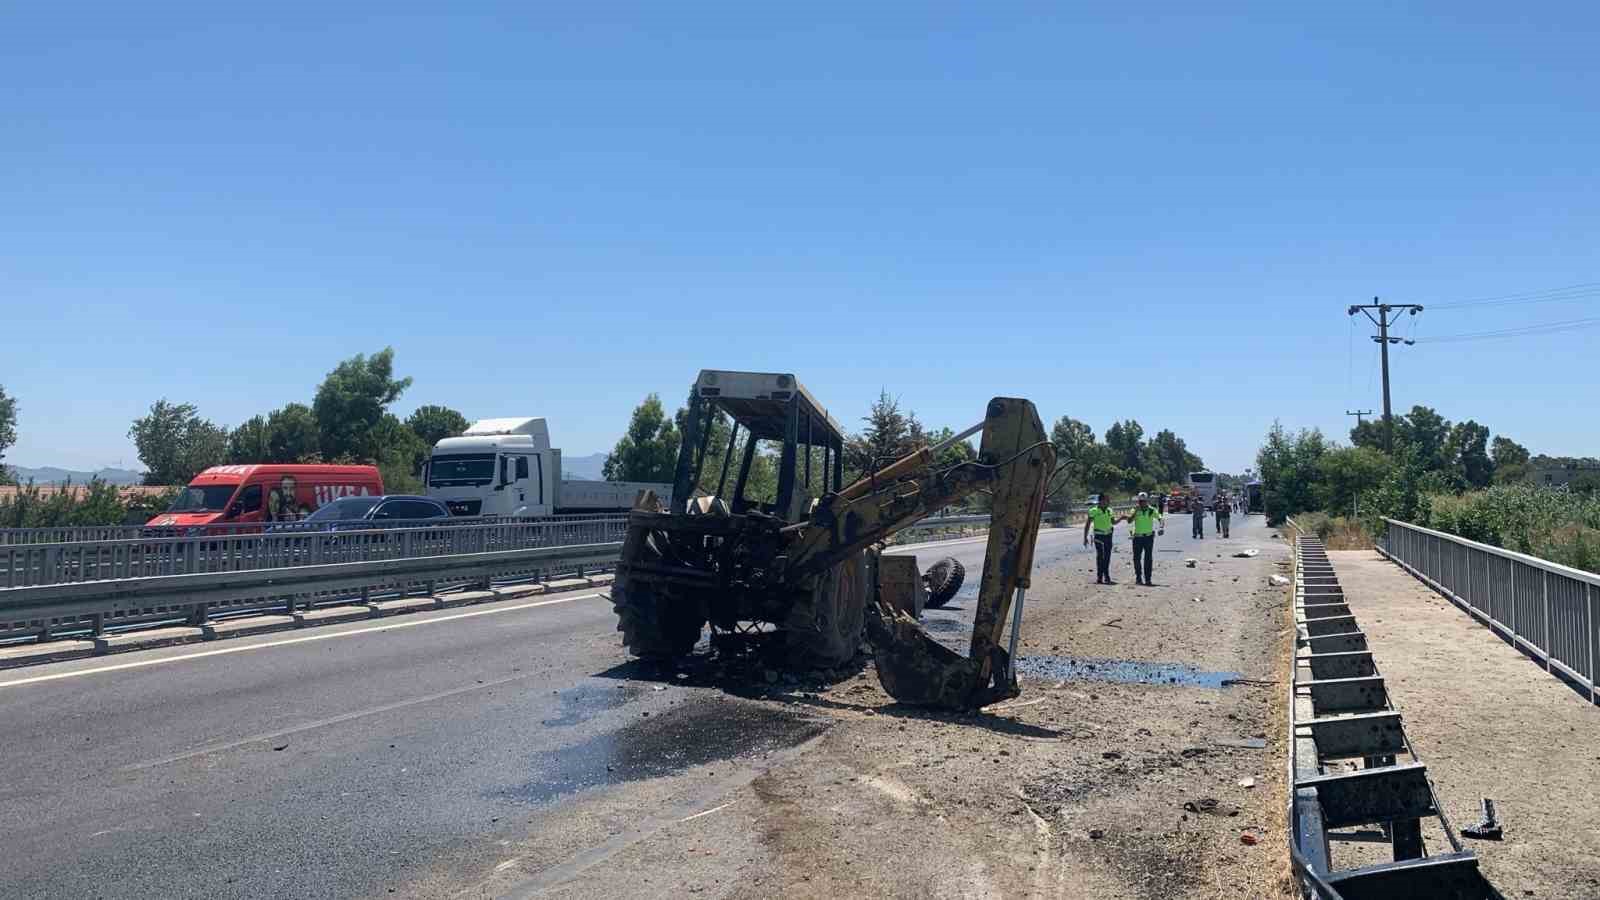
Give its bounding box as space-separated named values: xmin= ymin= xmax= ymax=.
xmin=867 ymin=397 xmax=1056 ymax=709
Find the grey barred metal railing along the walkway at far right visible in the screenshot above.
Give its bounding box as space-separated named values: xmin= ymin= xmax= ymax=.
xmin=1378 ymin=519 xmax=1600 ymax=703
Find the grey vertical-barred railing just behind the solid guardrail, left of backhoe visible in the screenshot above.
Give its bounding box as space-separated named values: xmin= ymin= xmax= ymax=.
xmin=0 ymin=516 xmax=627 ymax=588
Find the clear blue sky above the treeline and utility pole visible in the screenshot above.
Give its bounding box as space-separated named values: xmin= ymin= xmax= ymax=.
xmin=0 ymin=2 xmax=1600 ymax=471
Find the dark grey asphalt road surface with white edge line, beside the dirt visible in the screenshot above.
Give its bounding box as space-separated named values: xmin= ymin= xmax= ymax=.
xmin=0 ymin=517 xmax=1259 ymax=898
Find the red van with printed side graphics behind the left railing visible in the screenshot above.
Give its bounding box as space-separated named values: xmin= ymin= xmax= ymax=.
xmin=147 ymin=463 xmax=384 ymax=528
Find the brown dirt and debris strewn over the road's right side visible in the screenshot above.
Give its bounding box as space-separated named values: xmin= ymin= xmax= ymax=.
xmin=480 ymin=530 xmax=1291 ymax=900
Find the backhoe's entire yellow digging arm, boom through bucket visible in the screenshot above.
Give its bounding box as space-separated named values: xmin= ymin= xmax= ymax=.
xmin=782 ymin=397 xmax=1056 ymax=709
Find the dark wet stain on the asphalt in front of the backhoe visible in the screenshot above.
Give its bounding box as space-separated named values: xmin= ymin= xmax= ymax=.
xmin=494 ymin=689 xmax=829 ymax=804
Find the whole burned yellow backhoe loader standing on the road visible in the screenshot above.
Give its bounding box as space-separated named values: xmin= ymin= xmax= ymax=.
xmin=611 ymin=370 xmax=1056 ymax=709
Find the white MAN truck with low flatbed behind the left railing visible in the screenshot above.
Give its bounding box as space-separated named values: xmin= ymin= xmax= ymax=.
xmin=422 ymin=418 xmax=672 ymax=516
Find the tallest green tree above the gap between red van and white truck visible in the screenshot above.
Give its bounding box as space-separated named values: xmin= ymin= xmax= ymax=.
xmin=312 ymin=348 xmax=411 ymax=460
